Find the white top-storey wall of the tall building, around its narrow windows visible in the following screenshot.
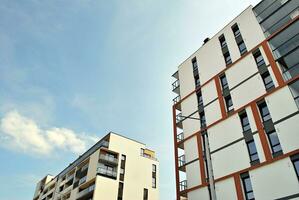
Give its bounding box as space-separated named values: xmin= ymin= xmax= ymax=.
xmin=179 ymin=7 xmax=265 ymax=97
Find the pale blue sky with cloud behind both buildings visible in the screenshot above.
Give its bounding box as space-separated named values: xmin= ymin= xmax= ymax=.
xmin=0 ymin=0 xmax=259 ymax=200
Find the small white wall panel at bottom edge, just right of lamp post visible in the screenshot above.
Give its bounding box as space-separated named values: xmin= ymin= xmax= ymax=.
xmin=215 ymin=178 xmax=238 ymax=200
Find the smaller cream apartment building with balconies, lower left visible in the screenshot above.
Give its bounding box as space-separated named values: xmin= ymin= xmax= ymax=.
xmin=33 ymin=132 xmax=159 ymax=200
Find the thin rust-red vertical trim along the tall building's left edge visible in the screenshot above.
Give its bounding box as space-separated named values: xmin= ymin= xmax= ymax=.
xmin=172 ymin=106 xmax=180 ymax=200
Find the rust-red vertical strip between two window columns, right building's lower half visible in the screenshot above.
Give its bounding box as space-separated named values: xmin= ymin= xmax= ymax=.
xmin=250 ymin=102 xmax=272 ymax=161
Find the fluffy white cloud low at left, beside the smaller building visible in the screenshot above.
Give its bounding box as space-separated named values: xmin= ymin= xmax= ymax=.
xmin=0 ymin=111 xmax=98 ymax=156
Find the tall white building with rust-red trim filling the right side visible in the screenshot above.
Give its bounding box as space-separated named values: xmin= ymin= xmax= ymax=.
xmin=173 ymin=0 xmax=299 ymax=200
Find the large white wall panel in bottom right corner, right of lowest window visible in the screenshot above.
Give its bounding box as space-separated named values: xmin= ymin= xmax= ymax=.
xmin=249 ymin=158 xmax=299 ymax=200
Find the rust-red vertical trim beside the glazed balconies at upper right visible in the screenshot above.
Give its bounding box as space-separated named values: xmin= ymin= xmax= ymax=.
xmin=262 ymin=40 xmax=284 ymax=86
